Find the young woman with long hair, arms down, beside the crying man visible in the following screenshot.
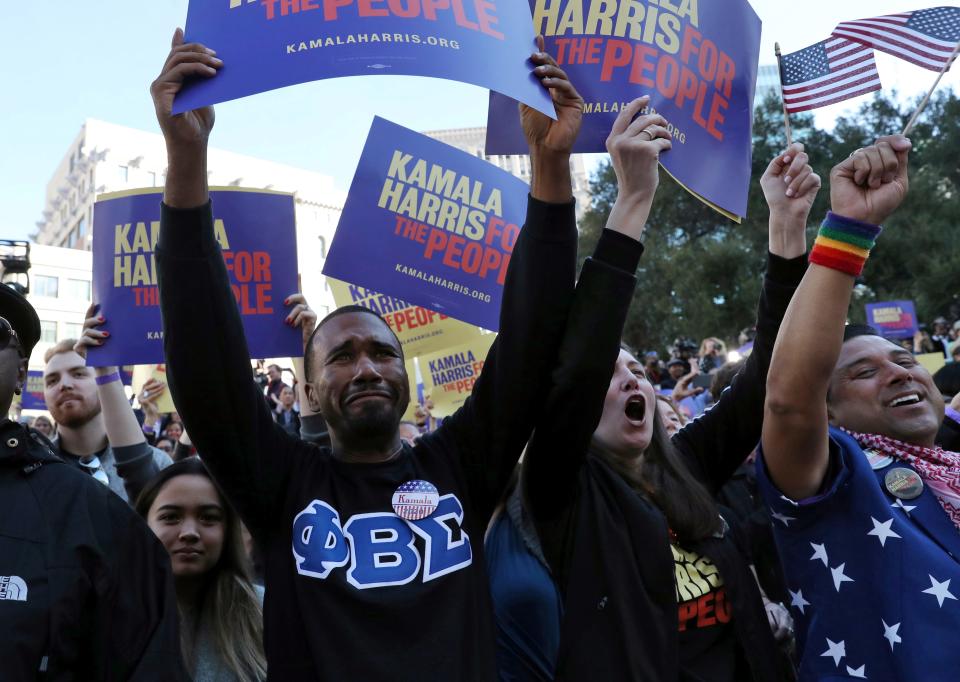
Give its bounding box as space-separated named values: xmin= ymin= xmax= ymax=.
xmin=136 ymin=457 xmax=267 ymax=682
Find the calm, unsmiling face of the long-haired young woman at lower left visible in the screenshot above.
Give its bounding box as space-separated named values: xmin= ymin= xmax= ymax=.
xmin=147 ymin=474 xmax=227 ymax=578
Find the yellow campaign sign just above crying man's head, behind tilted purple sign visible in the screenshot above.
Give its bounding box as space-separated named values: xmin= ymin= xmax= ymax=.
xmin=327 ymin=277 xmax=483 ymax=358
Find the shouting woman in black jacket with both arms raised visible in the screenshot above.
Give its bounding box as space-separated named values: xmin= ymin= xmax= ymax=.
xmin=498 ymin=99 xmax=820 ymax=682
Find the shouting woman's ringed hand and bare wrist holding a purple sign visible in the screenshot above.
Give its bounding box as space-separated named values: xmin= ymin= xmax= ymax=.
xmin=607 ymin=96 xmax=673 ymax=239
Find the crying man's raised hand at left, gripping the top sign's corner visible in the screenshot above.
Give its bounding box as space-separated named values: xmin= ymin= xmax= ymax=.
xmin=150 ymin=28 xmax=223 ymax=148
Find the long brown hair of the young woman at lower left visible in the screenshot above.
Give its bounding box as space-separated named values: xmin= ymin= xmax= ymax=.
xmin=136 ymin=457 xmax=267 ymax=682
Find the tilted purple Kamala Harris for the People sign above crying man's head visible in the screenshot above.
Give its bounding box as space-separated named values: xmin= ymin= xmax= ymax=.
xmin=323 ymin=113 xmax=529 ymax=331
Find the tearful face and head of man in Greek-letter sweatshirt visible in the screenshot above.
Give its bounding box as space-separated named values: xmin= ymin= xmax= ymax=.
xmin=305 ymin=313 xmax=410 ymax=448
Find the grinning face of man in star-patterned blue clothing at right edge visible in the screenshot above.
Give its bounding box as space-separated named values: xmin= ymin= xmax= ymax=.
xmin=827 ymin=336 xmax=944 ymax=446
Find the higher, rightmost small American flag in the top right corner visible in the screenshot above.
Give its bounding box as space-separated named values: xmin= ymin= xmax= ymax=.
xmin=833 ymin=7 xmax=960 ymax=71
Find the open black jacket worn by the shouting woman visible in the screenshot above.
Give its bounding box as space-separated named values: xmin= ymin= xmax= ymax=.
xmin=522 ymin=241 xmax=805 ymax=682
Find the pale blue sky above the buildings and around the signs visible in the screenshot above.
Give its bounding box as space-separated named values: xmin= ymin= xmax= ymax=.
xmin=0 ymin=0 xmax=960 ymax=239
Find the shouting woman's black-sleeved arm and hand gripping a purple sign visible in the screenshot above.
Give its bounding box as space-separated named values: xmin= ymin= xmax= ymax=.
xmin=522 ymin=97 xmax=671 ymax=516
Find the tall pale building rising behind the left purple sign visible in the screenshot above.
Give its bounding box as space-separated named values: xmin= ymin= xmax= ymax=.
xmin=31 ymin=119 xmax=346 ymax=318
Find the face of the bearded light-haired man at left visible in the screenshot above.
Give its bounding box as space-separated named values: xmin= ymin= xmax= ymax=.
xmin=43 ymin=351 xmax=100 ymax=428
